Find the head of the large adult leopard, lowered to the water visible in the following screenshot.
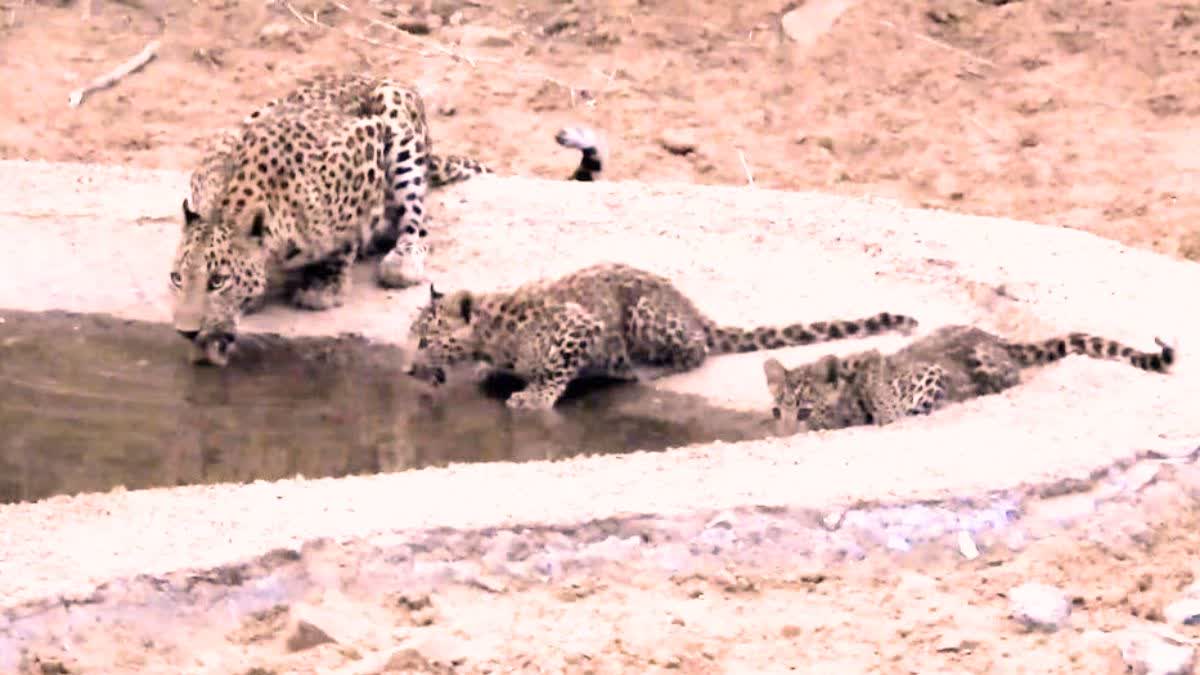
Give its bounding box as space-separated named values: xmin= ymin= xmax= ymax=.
xmin=169 ymin=199 xmax=268 ymax=366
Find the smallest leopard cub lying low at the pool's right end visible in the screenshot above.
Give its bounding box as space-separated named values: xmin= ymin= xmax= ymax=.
xmin=763 ymin=325 xmax=1175 ymax=434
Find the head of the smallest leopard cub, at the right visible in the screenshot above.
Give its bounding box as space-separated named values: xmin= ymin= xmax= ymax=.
xmin=762 ymin=356 xmax=842 ymax=435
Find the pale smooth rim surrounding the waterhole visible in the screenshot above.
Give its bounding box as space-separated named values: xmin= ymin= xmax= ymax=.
xmin=0 ymin=162 xmax=1200 ymax=603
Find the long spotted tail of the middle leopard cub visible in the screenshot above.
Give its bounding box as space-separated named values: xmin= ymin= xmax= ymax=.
xmin=706 ymin=312 xmax=918 ymax=354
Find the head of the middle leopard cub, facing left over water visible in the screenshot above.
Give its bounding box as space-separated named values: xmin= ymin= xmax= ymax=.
xmin=406 ymin=283 xmax=476 ymax=384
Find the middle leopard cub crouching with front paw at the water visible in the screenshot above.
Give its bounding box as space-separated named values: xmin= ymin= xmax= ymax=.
xmin=406 ymin=263 xmax=917 ymax=410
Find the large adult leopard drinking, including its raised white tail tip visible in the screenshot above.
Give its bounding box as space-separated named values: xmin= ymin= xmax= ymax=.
xmin=169 ymin=76 xmax=602 ymax=365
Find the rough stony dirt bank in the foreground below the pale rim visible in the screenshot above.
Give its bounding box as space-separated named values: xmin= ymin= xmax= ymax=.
xmin=0 ymin=448 xmax=1200 ymax=675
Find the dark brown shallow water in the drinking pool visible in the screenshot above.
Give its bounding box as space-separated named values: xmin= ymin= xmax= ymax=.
xmin=0 ymin=310 xmax=770 ymax=503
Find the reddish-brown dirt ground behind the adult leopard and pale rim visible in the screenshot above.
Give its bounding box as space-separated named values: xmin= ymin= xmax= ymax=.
xmin=7 ymin=0 xmax=1200 ymax=257
